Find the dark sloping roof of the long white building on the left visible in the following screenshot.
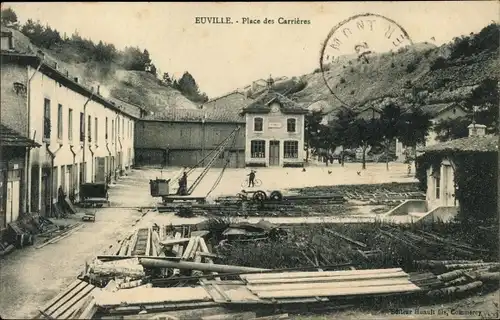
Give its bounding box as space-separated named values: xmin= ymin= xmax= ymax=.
xmin=1 ymin=51 xmax=140 ymax=118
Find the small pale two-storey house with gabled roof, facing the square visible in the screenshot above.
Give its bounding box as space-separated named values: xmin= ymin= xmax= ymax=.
xmin=243 ymin=90 xmax=308 ymax=167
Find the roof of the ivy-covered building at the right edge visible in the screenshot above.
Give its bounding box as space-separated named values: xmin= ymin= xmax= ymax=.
xmin=424 ymin=135 xmax=498 ymax=153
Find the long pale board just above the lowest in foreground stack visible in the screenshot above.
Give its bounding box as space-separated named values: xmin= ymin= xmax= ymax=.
xmin=247 ymin=277 xmax=411 ymax=292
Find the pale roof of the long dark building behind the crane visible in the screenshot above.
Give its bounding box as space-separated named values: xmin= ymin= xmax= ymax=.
xmin=142 ymin=108 xmax=245 ymax=123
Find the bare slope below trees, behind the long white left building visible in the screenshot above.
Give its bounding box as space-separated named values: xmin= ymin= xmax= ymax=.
xmin=2 ymin=28 xmax=198 ymax=112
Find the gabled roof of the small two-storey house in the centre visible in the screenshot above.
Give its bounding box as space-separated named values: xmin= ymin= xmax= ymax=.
xmin=243 ymin=90 xmax=309 ymax=114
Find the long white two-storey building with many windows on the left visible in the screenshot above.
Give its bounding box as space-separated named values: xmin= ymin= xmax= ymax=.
xmin=1 ymin=51 xmax=141 ymax=215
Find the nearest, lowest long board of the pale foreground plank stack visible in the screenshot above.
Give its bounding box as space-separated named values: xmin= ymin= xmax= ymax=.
xmin=257 ymin=284 xmax=420 ymax=299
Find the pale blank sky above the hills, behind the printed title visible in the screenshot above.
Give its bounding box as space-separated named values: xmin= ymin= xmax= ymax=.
xmin=2 ymin=1 xmax=500 ymax=98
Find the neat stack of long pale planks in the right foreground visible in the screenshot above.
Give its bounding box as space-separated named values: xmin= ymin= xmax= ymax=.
xmin=241 ymin=268 xmax=420 ymax=299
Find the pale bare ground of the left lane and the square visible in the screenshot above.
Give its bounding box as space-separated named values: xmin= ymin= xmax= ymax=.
xmin=0 ymin=164 xmax=438 ymax=318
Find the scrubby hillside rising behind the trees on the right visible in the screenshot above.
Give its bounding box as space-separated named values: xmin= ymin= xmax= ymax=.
xmin=262 ymin=24 xmax=500 ymax=117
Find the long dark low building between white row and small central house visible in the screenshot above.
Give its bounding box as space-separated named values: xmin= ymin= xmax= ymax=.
xmin=135 ymin=101 xmax=245 ymax=168
